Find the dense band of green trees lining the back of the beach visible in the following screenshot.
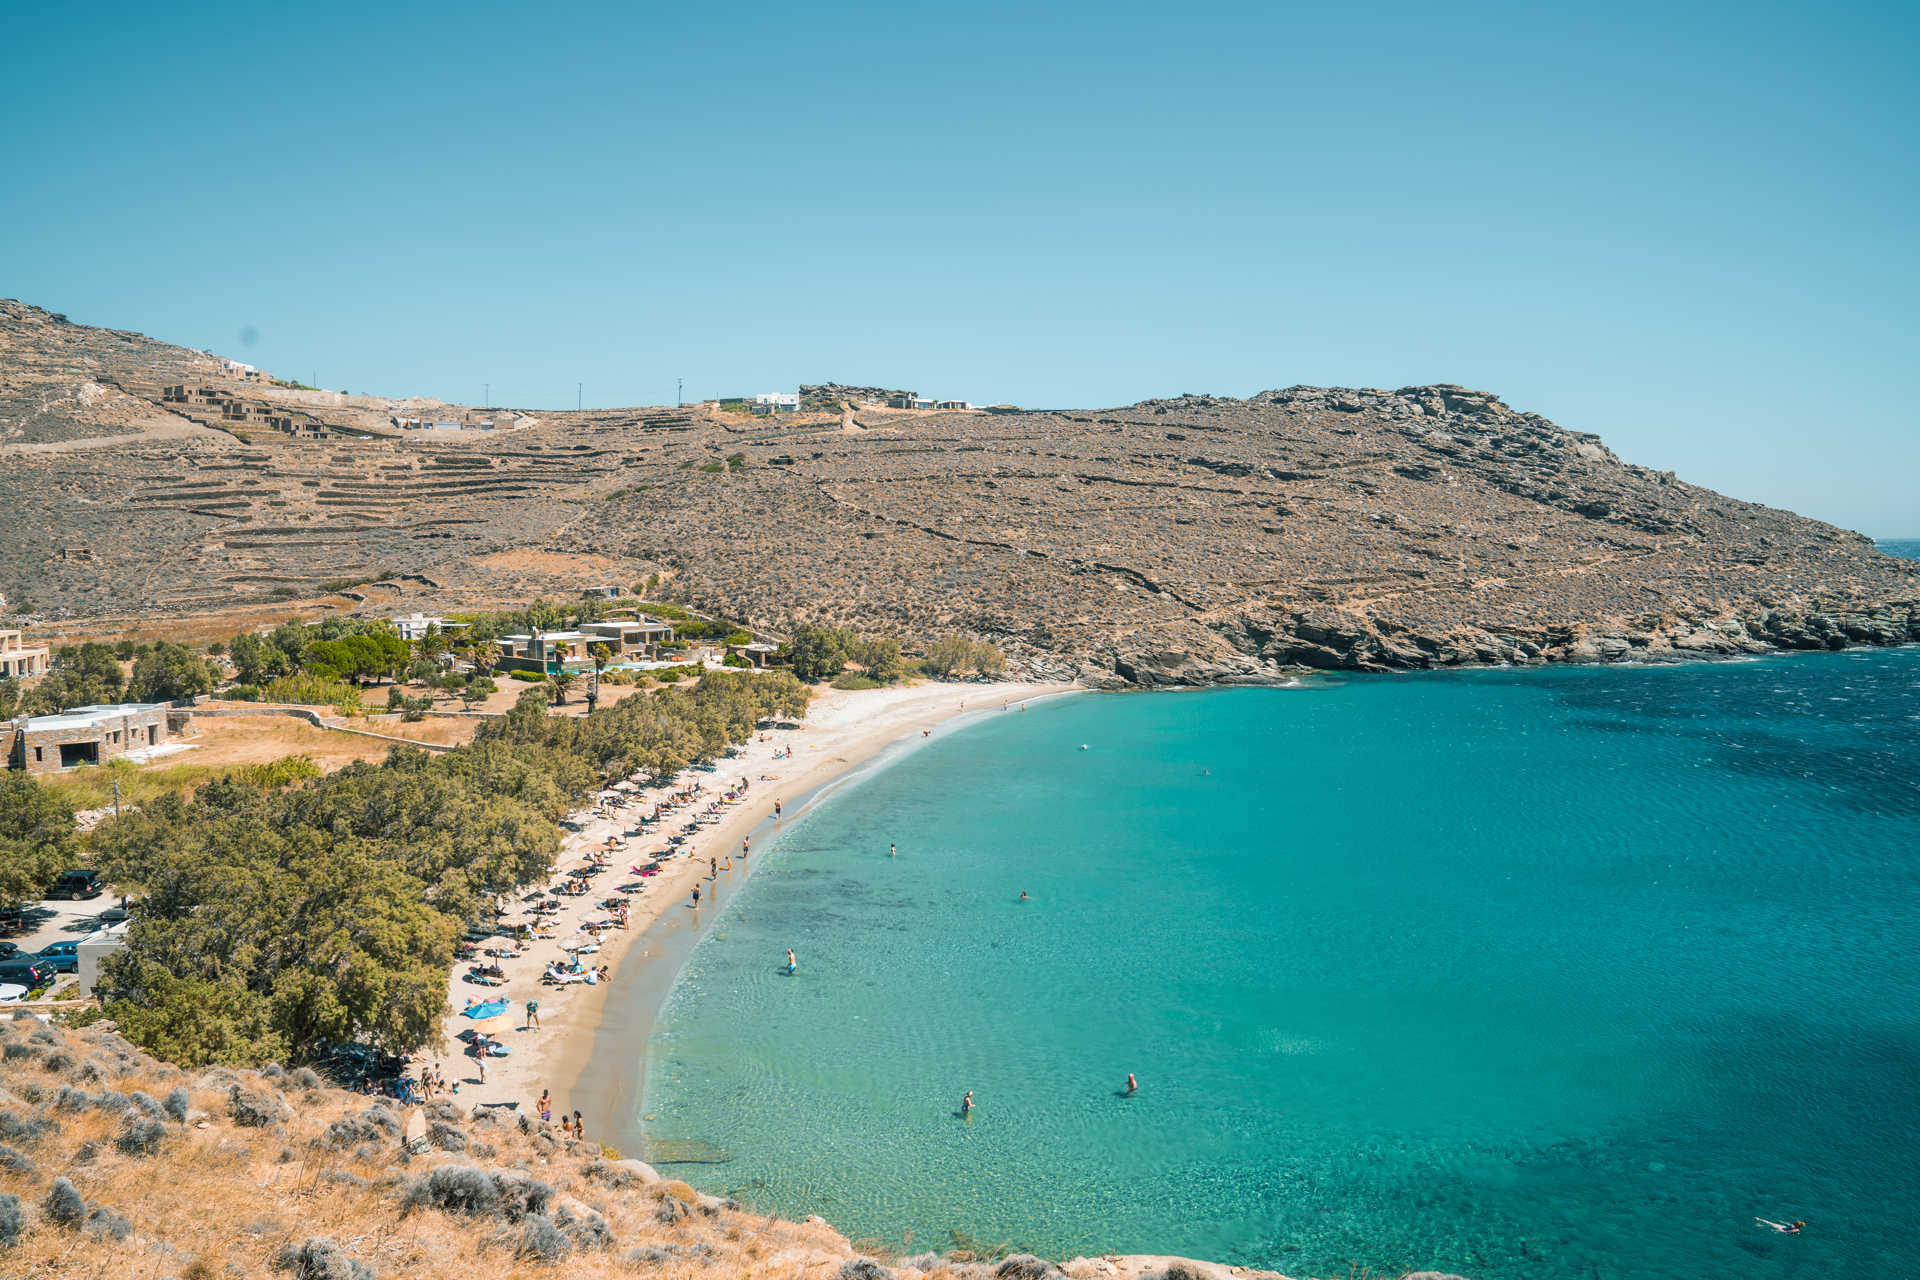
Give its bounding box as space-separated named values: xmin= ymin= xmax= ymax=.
xmin=76 ymin=674 xmax=808 ymax=1065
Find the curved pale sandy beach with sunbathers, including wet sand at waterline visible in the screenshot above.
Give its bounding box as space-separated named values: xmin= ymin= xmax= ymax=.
xmin=428 ymin=681 xmax=1085 ymax=1146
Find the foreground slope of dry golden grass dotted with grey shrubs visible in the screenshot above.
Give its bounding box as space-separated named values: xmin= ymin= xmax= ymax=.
xmin=0 ymin=1013 xmax=1320 ymax=1280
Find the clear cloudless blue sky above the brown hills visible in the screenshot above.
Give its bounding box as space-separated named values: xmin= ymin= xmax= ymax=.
xmin=0 ymin=0 xmax=1920 ymax=535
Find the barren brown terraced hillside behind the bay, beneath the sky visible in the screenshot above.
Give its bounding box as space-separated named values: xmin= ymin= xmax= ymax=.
xmin=0 ymin=303 xmax=1920 ymax=683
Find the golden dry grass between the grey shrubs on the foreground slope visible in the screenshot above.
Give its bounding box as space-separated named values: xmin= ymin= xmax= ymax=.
xmin=0 ymin=1021 xmax=852 ymax=1280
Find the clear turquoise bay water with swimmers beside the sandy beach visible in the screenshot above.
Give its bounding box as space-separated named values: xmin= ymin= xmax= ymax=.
xmin=643 ymin=629 xmax=1920 ymax=1280
